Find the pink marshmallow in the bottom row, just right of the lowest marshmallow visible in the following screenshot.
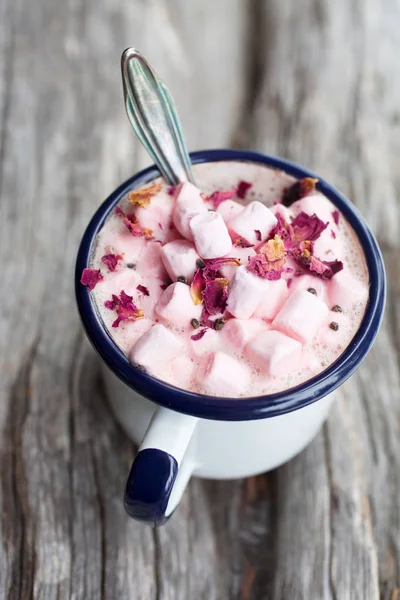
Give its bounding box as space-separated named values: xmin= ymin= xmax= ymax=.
xmin=246 ymin=330 xmax=302 ymax=377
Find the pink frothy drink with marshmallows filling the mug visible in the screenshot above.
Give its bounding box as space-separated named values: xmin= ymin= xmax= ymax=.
xmin=85 ymin=162 xmax=368 ymax=397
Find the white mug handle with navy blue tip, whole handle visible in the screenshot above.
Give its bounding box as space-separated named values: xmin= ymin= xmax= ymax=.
xmin=124 ymin=406 xmax=198 ymax=526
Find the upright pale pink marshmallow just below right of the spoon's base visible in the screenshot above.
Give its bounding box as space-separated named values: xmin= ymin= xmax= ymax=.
xmin=190 ymin=211 xmax=232 ymax=258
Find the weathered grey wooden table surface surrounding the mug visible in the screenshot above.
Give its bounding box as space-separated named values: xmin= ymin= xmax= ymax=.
xmin=0 ymin=0 xmax=400 ymax=600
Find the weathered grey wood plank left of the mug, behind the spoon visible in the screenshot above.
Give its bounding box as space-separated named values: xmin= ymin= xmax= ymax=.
xmin=0 ymin=0 xmax=250 ymax=600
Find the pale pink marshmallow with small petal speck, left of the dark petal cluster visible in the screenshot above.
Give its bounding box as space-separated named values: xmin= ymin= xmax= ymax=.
xmin=229 ymin=200 xmax=278 ymax=245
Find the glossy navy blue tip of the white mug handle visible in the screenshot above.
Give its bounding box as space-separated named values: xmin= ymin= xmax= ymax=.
xmin=124 ymin=448 xmax=178 ymax=526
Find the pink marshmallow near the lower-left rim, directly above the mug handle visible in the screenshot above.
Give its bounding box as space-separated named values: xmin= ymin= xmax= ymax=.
xmin=129 ymin=324 xmax=183 ymax=375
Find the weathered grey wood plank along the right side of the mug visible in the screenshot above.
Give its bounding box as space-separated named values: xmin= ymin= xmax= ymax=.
xmin=251 ymin=0 xmax=400 ymax=600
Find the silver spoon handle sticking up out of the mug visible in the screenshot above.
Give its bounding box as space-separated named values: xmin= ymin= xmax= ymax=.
xmin=121 ymin=48 xmax=194 ymax=185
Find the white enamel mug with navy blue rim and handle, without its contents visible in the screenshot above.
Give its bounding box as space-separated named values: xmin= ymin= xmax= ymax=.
xmin=76 ymin=150 xmax=386 ymax=525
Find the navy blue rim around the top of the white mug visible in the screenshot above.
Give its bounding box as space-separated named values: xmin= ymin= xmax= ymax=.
xmin=75 ymin=149 xmax=386 ymax=421
